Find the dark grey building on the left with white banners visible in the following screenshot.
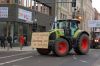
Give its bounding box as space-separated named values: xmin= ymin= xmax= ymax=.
xmin=0 ymin=0 xmax=55 ymax=44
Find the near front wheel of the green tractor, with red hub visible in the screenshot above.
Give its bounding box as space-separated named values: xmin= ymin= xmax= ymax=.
xmin=53 ymin=38 xmax=69 ymax=56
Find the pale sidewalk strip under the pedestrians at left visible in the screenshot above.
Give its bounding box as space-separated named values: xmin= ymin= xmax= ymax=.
xmin=0 ymin=46 xmax=35 ymax=51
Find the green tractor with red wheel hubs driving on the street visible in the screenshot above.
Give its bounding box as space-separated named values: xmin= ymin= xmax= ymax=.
xmin=37 ymin=19 xmax=89 ymax=56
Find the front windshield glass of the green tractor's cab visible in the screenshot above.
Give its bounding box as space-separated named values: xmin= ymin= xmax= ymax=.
xmin=52 ymin=21 xmax=68 ymax=29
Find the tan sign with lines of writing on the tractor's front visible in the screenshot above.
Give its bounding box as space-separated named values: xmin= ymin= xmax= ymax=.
xmin=31 ymin=32 xmax=49 ymax=48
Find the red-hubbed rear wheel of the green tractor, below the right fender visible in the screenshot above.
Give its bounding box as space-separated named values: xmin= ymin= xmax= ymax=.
xmin=74 ymin=34 xmax=89 ymax=55
